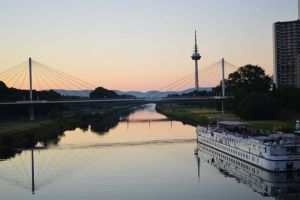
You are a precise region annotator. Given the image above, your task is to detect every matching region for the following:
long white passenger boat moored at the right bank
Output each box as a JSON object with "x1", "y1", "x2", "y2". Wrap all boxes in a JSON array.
[{"x1": 197, "y1": 121, "x2": 300, "y2": 172}]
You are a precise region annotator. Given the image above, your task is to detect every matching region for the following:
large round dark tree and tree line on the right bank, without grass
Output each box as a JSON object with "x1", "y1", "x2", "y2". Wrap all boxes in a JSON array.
[{"x1": 173, "y1": 65, "x2": 300, "y2": 120}]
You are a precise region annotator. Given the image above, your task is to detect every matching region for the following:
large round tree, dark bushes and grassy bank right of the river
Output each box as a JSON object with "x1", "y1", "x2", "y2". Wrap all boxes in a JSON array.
[{"x1": 157, "y1": 65, "x2": 300, "y2": 132}]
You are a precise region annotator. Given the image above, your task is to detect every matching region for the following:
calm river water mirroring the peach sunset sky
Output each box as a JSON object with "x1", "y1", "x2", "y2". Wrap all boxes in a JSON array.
[{"x1": 0, "y1": 104, "x2": 300, "y2": 200}]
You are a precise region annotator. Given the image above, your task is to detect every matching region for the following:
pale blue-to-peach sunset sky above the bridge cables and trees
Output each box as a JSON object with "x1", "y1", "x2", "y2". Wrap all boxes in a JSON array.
[{"x1": 0, "y1": 0, "x2": 298, "y2": 91}]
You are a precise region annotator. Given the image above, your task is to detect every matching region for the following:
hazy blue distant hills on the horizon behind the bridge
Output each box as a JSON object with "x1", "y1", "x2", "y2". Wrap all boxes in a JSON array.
[{"x1": 55, "y1": 88, "x2": 212, "y2": 98}]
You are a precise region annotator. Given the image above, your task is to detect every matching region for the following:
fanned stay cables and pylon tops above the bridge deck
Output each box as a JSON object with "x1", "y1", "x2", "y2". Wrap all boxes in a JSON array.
[{"x1": 0, "y1": 57, "x2": 237, "y2": 97}]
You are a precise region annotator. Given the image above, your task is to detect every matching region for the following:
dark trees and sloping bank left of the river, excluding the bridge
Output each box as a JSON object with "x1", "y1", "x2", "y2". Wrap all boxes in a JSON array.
[{"x1": 0, "y1": 78, "x2": 140, "y2": 159}]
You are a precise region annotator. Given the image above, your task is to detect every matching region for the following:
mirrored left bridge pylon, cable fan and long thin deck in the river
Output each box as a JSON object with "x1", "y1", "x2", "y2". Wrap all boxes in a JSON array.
[{"x1": 0, "y1": 139, "x2": 195, "y2": 194}]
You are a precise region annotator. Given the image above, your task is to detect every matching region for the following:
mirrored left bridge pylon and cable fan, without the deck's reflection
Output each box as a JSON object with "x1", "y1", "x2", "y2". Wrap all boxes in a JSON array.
[{"x1": 0, "y1": 145, "x2": 105, "y2": 194}]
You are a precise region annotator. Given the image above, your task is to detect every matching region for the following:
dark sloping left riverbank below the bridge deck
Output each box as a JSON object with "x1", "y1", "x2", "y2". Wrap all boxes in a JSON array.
[{"x1": 0, "y1": 106, "x2": 136, "y2": 156}]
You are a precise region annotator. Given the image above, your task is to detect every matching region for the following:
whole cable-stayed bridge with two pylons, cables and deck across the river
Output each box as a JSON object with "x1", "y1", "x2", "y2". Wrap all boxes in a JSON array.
[{"x1": 0, "y1": 58, "x2": 237, "y2": 119}]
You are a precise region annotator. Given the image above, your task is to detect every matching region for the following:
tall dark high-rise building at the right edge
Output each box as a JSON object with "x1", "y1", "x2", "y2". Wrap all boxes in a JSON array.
[{"x1": 274, "y1": 0, "x2": 300, "y2": 88}]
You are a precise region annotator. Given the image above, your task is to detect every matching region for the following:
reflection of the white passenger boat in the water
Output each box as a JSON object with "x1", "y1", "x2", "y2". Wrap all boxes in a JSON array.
[{"x1": 198, "y1": 143, "x2": 300, "y2": 199}]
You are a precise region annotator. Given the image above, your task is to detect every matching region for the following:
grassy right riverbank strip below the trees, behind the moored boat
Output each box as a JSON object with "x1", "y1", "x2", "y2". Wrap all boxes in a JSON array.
[{"x1": 156, "y1": 104, "x2": 296, "y2": 132}]
